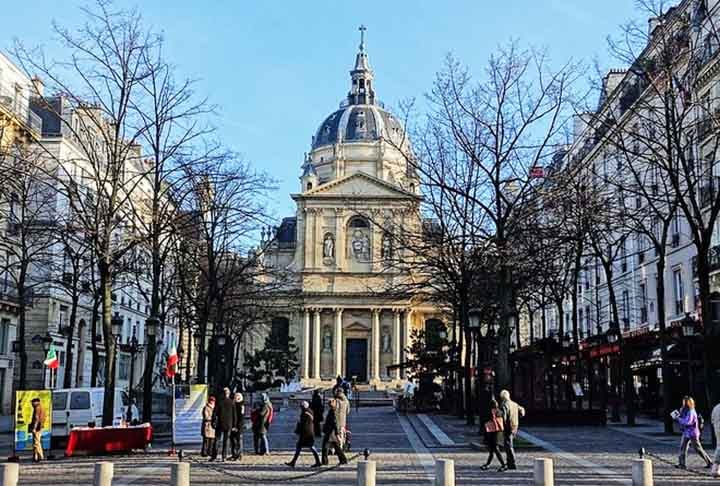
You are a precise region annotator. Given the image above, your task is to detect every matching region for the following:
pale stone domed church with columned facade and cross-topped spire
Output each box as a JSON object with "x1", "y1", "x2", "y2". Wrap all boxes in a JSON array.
[{"x1": 266, "y1": 29, "x2": 444, "y2": 388}]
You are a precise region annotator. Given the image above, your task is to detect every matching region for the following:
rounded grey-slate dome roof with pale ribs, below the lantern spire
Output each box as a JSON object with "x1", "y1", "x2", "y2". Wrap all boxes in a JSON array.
[{"x1": 312, "y1": 105, "x2": 402, "y2": 149}]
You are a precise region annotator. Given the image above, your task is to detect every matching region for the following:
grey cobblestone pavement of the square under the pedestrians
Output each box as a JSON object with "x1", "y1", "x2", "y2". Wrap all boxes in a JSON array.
[{"x1": 9, "y1": 407, "x2": 720, "y2": 486}]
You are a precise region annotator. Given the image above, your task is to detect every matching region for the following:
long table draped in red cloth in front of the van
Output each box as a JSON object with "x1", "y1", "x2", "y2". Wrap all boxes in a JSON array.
[{"x1": 65, "y1": 424, "x2": 152, "y2": 457}]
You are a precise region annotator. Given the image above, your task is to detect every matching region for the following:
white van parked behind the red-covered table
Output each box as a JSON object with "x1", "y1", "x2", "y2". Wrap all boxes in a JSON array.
[{"x1": 52, "y1": 387, "x2": 128, "y2": 440}]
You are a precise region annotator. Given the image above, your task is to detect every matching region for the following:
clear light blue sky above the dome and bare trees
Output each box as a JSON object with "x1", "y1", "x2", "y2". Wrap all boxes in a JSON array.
[{"x1": 0, "y1": 0, "x2": 637, "y2": 216}]
